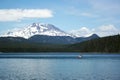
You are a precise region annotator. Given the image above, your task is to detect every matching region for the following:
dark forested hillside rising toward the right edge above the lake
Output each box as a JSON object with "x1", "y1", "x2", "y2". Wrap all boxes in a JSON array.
[{"x1": 69, "y1": 35, "x2": 120, "y2": 53}]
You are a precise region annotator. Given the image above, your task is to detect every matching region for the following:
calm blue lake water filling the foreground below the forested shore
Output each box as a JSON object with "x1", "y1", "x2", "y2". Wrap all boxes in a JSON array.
[{"x1": 0, "y1": 53, "x2": 120, "y2": 80}]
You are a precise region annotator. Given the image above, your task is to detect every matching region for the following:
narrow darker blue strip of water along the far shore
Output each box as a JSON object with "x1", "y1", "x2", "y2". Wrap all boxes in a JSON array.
[{"x1": 0, "y1": 52, "x2": 120, "y2": 59}]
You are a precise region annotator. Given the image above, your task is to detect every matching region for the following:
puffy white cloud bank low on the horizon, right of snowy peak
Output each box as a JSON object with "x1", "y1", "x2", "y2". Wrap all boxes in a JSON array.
[{"x1": 70, "y1": 24, "x2": 120, "y2": 37}]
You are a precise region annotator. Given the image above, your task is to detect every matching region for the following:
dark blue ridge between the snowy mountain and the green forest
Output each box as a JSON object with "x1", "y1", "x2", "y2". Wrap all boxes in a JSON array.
[{"x1": 0, "y1": 34, "x2": 99, "y2": 44}]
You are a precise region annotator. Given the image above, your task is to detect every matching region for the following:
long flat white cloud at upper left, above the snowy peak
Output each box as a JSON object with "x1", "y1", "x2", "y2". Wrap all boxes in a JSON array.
[{"x1": 0, "y1": 9, "x2": 53, "y2": 21}]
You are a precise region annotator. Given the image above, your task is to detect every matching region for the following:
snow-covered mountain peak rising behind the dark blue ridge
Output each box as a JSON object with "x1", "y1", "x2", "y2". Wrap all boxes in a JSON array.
[{"x1": 1, "y1": 23, "x2": 72, "y2": 39}]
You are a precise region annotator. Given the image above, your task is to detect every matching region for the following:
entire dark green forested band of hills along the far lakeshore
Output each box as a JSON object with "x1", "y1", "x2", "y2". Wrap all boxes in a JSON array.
[{"x1": 0, "y1": 35, "x2": 120, "y2": 53}]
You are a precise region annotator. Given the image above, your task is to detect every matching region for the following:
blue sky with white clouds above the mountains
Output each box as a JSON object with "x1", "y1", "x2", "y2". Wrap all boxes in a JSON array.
[{"x1": 0, "y1": 0, "x2": 120, "y2": 37}]
